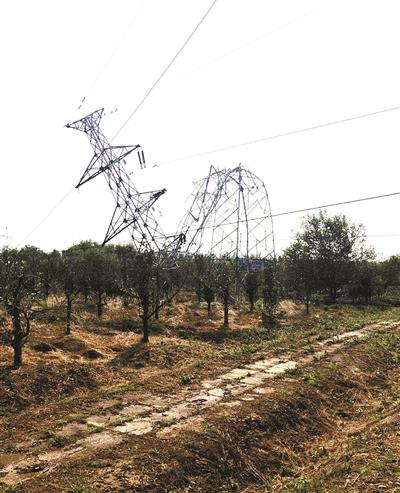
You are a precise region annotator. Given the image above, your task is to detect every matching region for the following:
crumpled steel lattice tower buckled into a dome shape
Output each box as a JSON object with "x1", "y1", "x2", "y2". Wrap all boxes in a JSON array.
[{"x1": 178, "y1": 165, "x2": 275, "y2": 268}]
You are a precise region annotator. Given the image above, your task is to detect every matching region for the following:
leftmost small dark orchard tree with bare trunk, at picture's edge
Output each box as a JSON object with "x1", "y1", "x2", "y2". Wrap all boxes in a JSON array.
[{"x1": 0, "y1": 247, "x2": 45, "y2": 368}]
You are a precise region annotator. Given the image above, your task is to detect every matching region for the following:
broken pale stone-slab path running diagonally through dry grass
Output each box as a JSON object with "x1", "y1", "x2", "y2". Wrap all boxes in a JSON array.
[{"x1": 0, "y1": 322, "x2": 398, "y2": 485}]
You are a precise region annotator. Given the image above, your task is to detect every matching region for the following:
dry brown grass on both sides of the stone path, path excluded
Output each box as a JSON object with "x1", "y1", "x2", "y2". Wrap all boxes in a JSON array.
[{"x1": 0, "y1": 297, "x2": 399, "y2": 493}]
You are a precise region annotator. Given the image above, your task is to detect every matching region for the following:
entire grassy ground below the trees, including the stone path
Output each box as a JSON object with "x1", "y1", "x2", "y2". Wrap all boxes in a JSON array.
[{"x1": 0, "y1": 294, "x2": 400, "y2": 493}]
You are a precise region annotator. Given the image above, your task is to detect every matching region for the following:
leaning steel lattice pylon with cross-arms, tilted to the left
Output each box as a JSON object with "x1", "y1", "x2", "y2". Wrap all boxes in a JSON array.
[{"x1": 66, "y1": 109, "x2": 184, "y2": 252}]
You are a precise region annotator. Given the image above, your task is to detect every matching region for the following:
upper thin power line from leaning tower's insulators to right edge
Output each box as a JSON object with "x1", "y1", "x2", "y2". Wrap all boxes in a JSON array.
[{"x1": 153, "y1": 105, "x2": 400, "y2": 167}]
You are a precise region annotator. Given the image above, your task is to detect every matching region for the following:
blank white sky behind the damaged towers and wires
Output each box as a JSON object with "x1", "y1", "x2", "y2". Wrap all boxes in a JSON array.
[{"x1": 0, "y1": 0, "x2": 400, "y2": 256}]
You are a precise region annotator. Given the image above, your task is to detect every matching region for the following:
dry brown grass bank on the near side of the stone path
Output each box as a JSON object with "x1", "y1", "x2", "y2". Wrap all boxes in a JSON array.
[{"x1": 17, "y1": 324, "x2": 400, "y2": 493}]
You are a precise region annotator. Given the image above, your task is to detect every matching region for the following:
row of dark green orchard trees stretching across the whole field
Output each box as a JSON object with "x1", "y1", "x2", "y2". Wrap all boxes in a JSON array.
[{"x1": 0, "y1": 212, "x2": 400, "y2": 367}]
